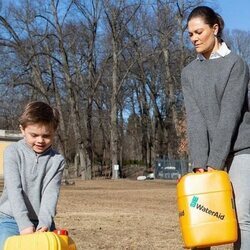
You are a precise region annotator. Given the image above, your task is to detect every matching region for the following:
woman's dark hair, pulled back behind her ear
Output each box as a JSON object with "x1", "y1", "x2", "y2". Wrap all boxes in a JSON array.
[{"x1": 187, "y1": 6, "x2": 224, "y2": 42}]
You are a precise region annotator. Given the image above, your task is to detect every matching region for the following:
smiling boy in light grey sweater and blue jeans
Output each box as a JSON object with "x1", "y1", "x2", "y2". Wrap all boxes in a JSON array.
[{"x1": 0, "y1": 102, "x2": 64, "y2": 250}]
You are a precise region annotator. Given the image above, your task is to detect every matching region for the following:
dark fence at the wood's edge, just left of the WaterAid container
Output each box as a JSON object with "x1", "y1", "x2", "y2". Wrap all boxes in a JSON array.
[{"x1": 155, "y1": 158, "x2": 189, "y2": 180}]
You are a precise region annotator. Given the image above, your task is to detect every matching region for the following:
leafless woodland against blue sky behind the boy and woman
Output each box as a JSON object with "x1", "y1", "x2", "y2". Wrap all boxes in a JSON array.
[{"x1": 0, "y1": 0, "x2": 250, "y2": 179}]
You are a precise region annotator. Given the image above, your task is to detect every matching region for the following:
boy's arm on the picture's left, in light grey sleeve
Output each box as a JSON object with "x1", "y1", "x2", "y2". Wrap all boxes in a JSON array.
[{"x1": 4, "y1": 147, "x2": 33, "y2": 232}]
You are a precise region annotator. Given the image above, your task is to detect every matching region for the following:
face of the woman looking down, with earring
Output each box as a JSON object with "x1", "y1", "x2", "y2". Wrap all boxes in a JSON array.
[{"x1": 188, "y1": 17, "x2": 219, "y2": 59}]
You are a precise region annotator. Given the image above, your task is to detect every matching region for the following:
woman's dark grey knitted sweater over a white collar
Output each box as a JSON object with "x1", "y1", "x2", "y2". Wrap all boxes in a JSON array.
[{"x1": 182, "y1": 52, "x2": 250, "y2": 169}]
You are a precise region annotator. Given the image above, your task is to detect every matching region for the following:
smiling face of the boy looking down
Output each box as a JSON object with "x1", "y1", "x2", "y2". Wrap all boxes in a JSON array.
[{"x1": 20, "y1": 123, "x2": 55, "y2": 154}]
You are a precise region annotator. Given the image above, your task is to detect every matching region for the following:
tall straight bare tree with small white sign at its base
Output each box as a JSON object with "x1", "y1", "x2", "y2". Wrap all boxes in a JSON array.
[{"x1": 103, "y1": 0, "x2": 140, "y2": 178}]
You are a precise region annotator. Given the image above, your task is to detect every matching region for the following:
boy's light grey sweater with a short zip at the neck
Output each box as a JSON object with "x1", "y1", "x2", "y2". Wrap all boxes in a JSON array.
[{"x1": 0, "y1": 139, "x2": 64, "y2": 231}]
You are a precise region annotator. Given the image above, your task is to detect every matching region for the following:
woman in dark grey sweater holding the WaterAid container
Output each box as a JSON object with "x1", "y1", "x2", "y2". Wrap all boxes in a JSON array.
[{"x1": 182, "y1": 6, "x2": 250, "y2": 250}]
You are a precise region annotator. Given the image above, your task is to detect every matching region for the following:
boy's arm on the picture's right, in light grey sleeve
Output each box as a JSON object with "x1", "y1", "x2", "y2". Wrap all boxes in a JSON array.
[{"x1": 37, "y1": 160, "x2": 65, "y2": 230}]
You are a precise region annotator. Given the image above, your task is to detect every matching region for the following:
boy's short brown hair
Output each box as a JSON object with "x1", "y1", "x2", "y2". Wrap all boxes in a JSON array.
[{"x1": 19, "y1": 101, "x2": 59, "y2": 130}]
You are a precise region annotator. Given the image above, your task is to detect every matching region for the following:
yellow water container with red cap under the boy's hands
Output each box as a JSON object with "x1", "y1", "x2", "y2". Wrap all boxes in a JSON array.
[{"x1": 4, "y1": 230, "x2": 76, "y2": 250}]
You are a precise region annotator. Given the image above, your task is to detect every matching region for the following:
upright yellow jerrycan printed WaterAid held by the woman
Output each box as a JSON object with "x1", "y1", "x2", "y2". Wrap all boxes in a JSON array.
[{"x1": 177, "y1": 170, "x2": 238, "y2": 248}]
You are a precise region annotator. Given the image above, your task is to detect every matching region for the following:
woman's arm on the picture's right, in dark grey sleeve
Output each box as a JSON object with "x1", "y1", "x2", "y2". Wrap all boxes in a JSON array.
[{"x1": 208, "y1": 58, "x2": 249, "y2": 169}]
